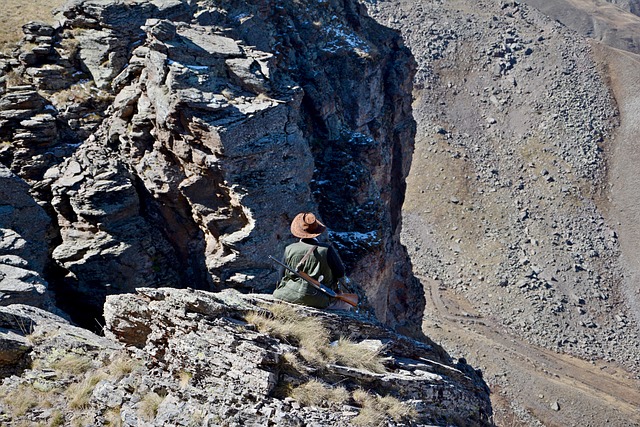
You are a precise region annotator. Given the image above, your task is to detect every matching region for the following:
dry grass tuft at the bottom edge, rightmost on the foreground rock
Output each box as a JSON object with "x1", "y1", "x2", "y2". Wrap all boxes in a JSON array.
[{"x1": 351, "y1": 390, "x2": 418, "y2": 426}]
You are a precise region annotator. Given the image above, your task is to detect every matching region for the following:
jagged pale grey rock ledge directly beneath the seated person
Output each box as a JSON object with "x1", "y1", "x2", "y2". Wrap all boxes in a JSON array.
[{"x1": 104, "y1": 288, "x2": 491, "y2": 426}]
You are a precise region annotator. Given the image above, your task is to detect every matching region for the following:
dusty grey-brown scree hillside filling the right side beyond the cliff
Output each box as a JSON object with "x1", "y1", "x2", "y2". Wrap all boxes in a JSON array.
[{"x1": 370, "y1": 1, "x2": 640, "y2": 426}]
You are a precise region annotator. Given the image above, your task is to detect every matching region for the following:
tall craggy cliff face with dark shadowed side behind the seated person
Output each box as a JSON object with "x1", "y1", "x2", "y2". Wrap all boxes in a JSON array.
[{"x1": 0, "y1": 0, "x2": 424, "y2": 332}]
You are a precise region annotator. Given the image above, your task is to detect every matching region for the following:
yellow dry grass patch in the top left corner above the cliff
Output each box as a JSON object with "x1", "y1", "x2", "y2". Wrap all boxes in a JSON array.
[{"x1": 0, "y1": 0, "x2": 65, "y2": 49}]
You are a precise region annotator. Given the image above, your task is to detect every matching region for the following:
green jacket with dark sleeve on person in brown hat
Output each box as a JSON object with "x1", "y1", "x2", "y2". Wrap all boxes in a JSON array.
[{"x1": 273, "y1": 239, "x2": 344, "y2": 308}]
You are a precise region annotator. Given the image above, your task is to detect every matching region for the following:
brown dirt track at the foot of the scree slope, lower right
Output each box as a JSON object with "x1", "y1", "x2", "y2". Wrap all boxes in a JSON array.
[{"x1": 420, "y1": 277, "x2": 640, "y2": 427}]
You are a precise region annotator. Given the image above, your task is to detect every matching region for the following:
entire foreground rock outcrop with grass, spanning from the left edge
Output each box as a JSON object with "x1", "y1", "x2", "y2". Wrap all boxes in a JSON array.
[{"x1": 0, "y1": 288, "x2": 491, "y2": 426}]
